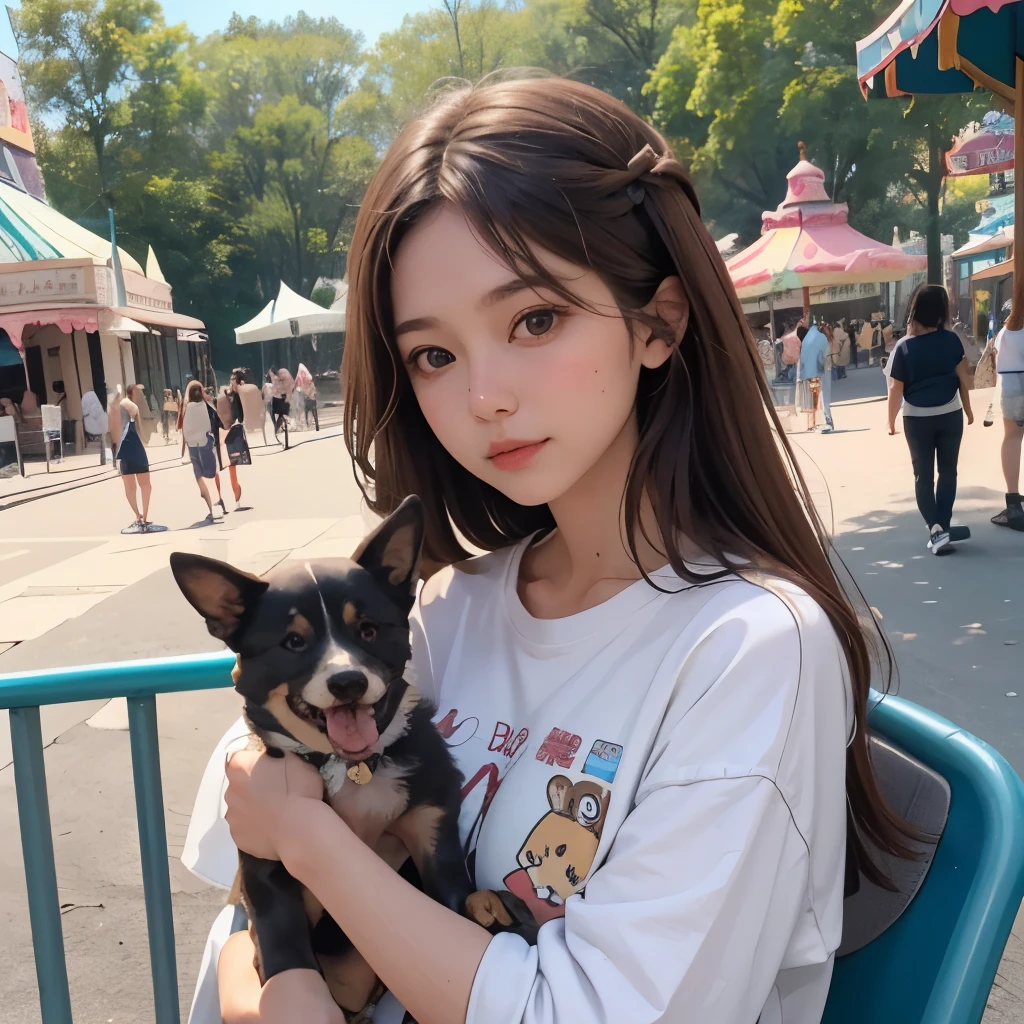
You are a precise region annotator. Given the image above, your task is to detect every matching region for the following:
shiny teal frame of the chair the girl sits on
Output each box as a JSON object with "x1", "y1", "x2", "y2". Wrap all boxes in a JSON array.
[{"x1": 822, "y1": 697, "x2": 1024, "y2": 1024}]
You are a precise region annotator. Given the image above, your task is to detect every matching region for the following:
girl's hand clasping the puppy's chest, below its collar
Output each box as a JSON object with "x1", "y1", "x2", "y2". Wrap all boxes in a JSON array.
[{"x1": 224, "y1": 750, "x2": 325, "y2": 860}]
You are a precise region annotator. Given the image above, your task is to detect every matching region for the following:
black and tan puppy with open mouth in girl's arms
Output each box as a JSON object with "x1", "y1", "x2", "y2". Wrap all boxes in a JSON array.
[{"x1": 171, "y1": 498, "x2": 470, "y2": 1013}]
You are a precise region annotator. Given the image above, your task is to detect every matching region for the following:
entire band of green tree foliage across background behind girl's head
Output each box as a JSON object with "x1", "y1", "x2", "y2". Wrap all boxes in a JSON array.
[{"x1": 15, "y1": 0, "x2": 1007, "y2": 365}]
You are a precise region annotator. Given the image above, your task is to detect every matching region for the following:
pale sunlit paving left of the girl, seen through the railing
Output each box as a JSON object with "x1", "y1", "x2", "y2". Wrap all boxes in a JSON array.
[{"x1": 0, "y1": 419, "x2": 376, "y2": 1024}]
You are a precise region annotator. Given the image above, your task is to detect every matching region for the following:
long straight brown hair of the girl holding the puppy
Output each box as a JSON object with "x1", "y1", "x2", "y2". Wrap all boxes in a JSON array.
[{"x1": 343, "y1": 79, "x2": 910, "y2": 881}]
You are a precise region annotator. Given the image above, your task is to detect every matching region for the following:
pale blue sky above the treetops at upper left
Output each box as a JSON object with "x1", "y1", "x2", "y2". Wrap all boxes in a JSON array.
[{"x1": 0, "y1": 0, "x2": 433, "y2": 56}]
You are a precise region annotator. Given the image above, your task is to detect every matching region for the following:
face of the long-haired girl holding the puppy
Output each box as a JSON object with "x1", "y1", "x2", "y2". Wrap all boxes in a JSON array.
[{"x1": 392, "y1": 206, "x2": 670, "y2": 505}]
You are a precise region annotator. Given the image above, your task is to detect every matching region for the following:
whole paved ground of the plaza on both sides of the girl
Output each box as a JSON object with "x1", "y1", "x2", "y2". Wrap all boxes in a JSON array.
[{"x1": 0, "y1": 370, "x2": 1024, "y2": 1024}]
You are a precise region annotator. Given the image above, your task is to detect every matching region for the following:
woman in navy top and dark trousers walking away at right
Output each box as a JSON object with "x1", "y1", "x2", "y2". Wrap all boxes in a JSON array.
[{"x1": 885, "y1": 285, "x2": 974, "y2": 555}]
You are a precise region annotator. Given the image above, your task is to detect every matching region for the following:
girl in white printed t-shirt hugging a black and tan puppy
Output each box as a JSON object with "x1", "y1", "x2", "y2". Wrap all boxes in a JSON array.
[{"x1": 185, "y1": 80, "x2": 906, "y2": 1024}]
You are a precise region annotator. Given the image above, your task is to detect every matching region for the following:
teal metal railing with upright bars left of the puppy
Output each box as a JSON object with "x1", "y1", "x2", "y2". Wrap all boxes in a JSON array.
[{"x1": 0, "y1": 653, "x2": 234, "y2": 1024}]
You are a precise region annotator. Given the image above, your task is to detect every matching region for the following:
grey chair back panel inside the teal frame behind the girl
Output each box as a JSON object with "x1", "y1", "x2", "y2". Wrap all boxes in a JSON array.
[{"x1": 837, "y1": 735, "x2": 949, "y2": 956}]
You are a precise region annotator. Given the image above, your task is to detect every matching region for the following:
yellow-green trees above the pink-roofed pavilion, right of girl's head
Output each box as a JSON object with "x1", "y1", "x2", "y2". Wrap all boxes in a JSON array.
[{"x1": 648, "y1": 0, "x2": 985, "y2": 280}]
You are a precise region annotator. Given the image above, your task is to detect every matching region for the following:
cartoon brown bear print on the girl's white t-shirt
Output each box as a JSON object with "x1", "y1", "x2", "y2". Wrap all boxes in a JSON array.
[{"x1": 466, "y1": 775, "x2": 611, "y2": 941}]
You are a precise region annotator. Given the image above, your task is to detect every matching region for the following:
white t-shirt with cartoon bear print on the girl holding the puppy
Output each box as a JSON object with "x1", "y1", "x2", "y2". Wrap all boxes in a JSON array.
[{"x1": 182, "y1": 542, "x2": 852, "y2": 1024}]
